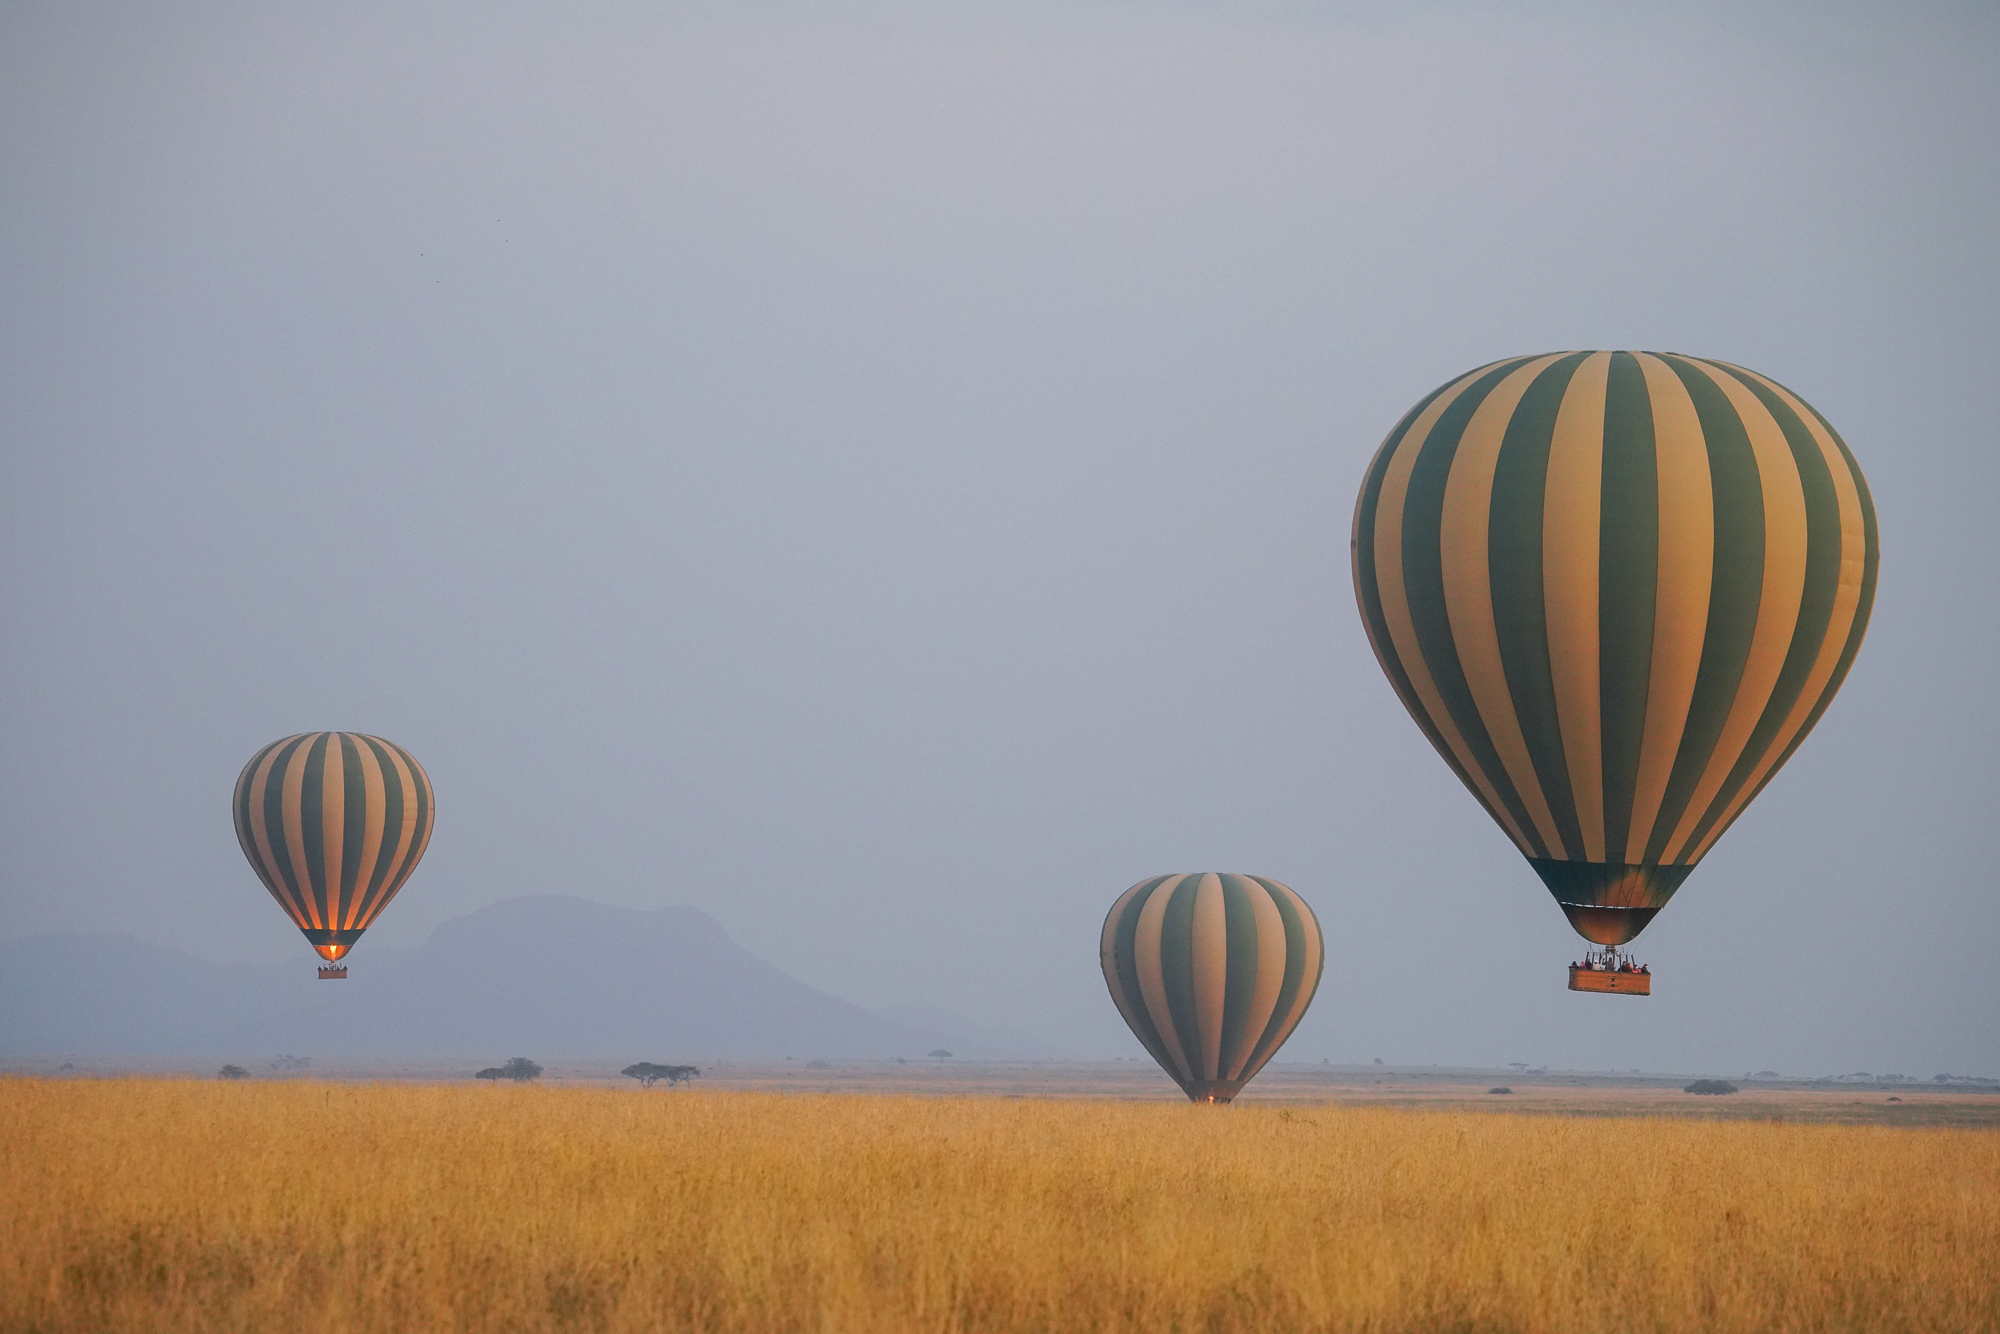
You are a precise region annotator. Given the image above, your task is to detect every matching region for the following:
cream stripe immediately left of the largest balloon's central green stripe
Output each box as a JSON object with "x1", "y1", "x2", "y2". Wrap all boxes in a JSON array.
[{"x1": 1542, "y1": 352, "x2": 1612, "y2": 862}]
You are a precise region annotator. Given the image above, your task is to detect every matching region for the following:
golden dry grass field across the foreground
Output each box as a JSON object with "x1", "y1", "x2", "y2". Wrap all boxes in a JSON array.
[{"x1": 0, "y1": 1078, "x2": 2000, "y2": 1334}]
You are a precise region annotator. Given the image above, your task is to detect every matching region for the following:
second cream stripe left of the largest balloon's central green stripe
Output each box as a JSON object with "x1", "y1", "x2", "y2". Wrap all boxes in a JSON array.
[{"x1": 1440, "y1": 352, "x2": 1570, "y2": 858}]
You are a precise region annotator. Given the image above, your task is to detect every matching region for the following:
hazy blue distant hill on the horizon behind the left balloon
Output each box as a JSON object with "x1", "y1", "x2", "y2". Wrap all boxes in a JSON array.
[{"x1": 0, "y1": 896, "x2": 1050, "y2": 1060}]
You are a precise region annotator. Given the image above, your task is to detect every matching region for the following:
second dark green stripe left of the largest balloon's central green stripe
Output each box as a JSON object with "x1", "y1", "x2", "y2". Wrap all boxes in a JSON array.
[{"x1": 1402, "y1": 356, "x2": 1548, "y2": 856}]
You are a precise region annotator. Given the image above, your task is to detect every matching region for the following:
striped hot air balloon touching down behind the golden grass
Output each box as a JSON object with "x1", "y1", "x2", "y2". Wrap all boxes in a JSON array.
[{"x1": 1098, "y1": 872, "x2": 1324, "y2": 1102}]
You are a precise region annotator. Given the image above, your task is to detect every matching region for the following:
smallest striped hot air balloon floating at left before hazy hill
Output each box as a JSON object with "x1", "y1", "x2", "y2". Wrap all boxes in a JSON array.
[{"x1": 234, "y1": 732, "x2": 432, "y2": 978}]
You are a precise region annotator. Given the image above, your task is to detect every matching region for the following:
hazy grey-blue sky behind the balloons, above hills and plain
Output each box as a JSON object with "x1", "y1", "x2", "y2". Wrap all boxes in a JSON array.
[{"x1": 0, "y1": 0, "x2": 2000, "y2": 1076}]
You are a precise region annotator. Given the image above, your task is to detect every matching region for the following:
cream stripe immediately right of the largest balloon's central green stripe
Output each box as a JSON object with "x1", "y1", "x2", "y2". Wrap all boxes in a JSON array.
[{"x1": 1624, "y1": 352, "x2": 1716, "y2": 862}]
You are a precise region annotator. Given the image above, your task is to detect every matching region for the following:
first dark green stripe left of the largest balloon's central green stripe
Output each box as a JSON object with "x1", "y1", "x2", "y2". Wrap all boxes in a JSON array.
[{"x1": 1486, "y1": 352, "x2": 1590, "y2": 856}]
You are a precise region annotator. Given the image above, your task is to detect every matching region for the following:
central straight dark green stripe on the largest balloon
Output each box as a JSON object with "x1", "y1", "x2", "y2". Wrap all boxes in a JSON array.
[{"x1": 1598, "y1": 352, "x2": 1660, "y2": 860}]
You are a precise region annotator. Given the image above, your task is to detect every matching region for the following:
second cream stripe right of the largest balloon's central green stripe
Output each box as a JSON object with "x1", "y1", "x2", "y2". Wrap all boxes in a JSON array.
[{"x1": 1660, "y1": 358, "x2": 1806, "y2": 862}]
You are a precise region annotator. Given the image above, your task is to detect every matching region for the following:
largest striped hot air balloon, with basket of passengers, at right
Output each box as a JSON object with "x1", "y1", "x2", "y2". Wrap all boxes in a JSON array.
[{"x1": 1352, "y1": 352, "x2": 1878, "y2": 992}]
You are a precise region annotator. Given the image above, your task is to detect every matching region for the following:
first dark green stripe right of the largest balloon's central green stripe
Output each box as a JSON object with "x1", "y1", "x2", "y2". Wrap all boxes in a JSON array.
[{"x1": 1646, "y1": 354, "x2": 1764, "y2": 862}]
